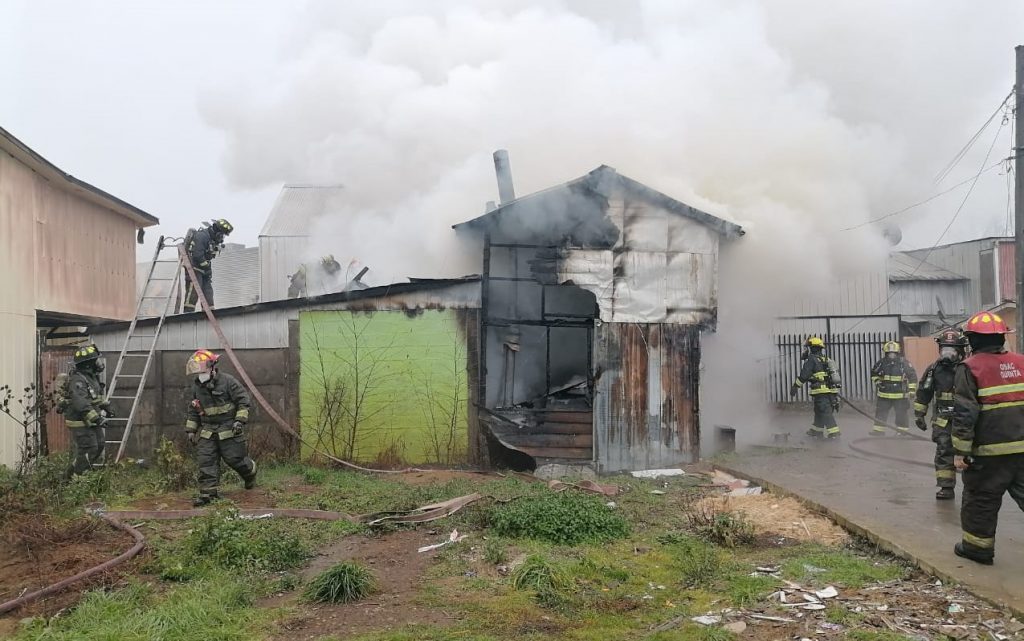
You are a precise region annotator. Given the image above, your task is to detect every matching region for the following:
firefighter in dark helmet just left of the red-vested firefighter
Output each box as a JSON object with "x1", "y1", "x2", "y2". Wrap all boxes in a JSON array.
[{"x1": 913, "y1": 329, "x2": 967, "y2": 501}]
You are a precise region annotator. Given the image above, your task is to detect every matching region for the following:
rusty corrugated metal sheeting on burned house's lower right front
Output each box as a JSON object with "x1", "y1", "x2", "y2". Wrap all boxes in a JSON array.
[{"x1": 594, "y1": 323, "x2": 700, "y2": 472}]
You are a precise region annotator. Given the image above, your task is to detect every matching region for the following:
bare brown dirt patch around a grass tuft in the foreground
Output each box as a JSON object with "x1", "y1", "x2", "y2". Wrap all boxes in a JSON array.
[{"x1": 260, "y1": 530, "x2": 452, "y2": 641}]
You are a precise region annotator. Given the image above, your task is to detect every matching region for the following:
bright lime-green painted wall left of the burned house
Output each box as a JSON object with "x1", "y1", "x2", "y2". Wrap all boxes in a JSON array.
[{"x1": 299, "y1": 310, "x2": 469, "y2": 465}]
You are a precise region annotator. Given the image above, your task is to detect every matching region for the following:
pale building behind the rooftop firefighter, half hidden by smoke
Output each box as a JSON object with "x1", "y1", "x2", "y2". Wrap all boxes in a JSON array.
[{"x1": 258, "y1": 184, "x2": 346, "y2": 304}]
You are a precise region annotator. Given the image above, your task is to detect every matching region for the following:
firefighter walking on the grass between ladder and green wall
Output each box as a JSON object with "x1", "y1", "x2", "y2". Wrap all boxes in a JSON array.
[{"x1": 185, "y1": 349, "x2": 256, "y2": 507}]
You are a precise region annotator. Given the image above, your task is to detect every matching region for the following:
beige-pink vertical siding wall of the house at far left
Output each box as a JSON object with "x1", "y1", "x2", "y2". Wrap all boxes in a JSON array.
[{"x1": 0, "y1": 152, "x2": 136, "y2": 465}]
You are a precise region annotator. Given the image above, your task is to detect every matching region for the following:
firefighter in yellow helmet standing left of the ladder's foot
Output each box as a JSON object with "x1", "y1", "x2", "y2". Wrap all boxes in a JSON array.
[{"x1": 62, "y1": 344, "x2": 114, "y2": 477}]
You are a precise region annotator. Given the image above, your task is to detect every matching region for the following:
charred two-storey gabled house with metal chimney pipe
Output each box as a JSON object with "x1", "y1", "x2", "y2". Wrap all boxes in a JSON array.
[{"x1": 455, "y1": 152, "x2": 743, "y2": 472}]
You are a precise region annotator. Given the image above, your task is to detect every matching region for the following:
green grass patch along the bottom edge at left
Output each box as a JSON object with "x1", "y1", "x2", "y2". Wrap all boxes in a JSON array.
[{"x1": 14, "y1": 574, "x2": 269, "y2": 641}]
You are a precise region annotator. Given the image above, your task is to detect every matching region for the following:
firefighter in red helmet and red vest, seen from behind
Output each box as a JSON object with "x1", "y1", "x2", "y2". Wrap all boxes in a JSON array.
[{"x1": 952, "y1": 311, "x2": 1024, "y2": 565}]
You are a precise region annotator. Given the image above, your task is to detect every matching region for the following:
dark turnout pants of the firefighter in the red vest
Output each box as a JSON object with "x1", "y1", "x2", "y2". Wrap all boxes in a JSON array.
[{"x1": 961, "y1": 454, "x2": 1024, "y2": 558}]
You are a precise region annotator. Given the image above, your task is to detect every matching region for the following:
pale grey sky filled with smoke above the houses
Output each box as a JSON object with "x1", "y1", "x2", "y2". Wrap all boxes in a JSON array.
[{"x1": 0, "y1": 0, "x2": 1024, "y2": 276}]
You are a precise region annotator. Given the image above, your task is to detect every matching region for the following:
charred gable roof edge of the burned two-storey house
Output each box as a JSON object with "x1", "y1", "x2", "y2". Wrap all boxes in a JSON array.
[{"x1": 452, "y1": 165, "x2": 745, "y2": 238}]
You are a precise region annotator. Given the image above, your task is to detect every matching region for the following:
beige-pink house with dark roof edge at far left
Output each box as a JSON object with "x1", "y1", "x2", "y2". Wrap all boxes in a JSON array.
[{"x1": 0, "y1": 124, "x2": 159, "y2": 466}]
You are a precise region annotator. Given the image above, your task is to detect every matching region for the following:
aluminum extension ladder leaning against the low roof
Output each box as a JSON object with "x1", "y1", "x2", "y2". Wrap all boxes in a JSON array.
[{"x1": 103, "y1": 237, "x2": 184, "y2": 463}]
